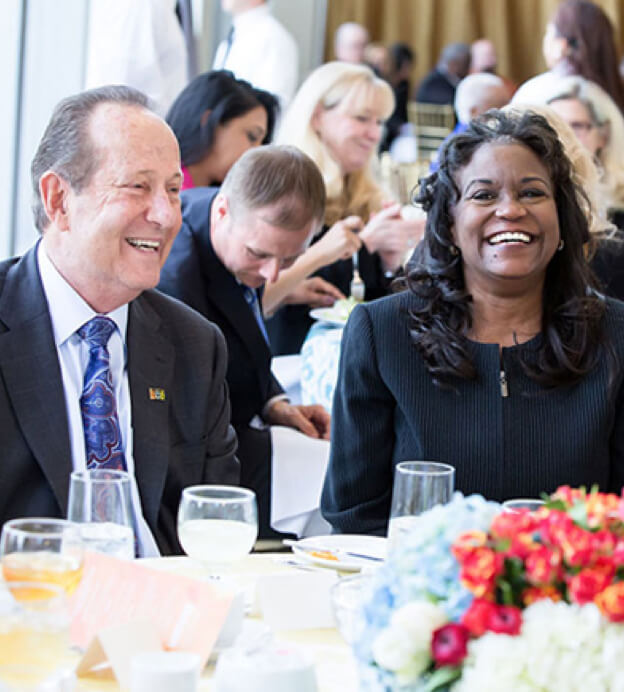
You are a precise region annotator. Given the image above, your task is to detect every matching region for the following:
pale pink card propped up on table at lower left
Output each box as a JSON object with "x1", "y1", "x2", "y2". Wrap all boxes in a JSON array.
[{"x1": 69, "y1": 552, "x2": 234, "y2": 674}]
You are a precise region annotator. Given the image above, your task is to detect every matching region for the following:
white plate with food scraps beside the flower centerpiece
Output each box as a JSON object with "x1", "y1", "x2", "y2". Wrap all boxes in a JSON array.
[{"x1": 292, "y1": 534, "x2": 387, "y2": 572}]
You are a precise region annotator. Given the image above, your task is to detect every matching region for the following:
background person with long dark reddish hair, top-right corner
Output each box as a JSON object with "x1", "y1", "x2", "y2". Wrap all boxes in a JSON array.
[{"x1": 514, "y1": 0, "x2": 624, "y2": 112}]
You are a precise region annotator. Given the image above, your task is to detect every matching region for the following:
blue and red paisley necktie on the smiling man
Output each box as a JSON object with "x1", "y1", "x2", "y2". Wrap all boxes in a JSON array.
[{"x1": 78, "y1": 316, "x2": 126, "y2": 471}]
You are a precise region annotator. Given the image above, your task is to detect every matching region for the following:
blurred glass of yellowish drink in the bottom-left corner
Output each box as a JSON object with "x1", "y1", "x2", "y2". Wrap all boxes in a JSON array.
[{"x1": 0, "y1": 582, "x2": 74, "y2": 690}]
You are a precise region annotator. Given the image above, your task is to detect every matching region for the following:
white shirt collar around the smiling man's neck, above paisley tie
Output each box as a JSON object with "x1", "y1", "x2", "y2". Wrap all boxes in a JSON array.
[{"x1": 37, "y1": 243, "x2": 128, "y2": 347}]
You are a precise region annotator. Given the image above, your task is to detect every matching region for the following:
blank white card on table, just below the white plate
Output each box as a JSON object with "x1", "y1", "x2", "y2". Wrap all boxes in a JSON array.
[{"x1": 257, "y1": 570, "x2": 338, "y2": 630}]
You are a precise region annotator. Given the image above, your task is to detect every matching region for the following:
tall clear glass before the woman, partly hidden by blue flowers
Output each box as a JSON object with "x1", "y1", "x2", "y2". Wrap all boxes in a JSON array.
[{"x1": 388, "y1": 461, "x2": 455, "y2": 552}]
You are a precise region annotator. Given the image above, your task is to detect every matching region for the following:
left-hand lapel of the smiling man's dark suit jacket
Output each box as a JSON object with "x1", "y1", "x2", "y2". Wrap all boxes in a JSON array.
[{"x1": 0, "y1": 247, "x2": 72, "y2": 513}]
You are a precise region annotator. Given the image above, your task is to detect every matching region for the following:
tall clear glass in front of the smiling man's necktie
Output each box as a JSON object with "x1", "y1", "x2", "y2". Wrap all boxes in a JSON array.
[{"x1": 67, "y1": 469, "x2": 134, "y2": 560}]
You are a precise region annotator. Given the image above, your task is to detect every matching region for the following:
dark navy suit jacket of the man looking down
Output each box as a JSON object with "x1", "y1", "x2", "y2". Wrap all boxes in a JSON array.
[{"x1": 158, "y1": 187, "x2": 284, "y2": 538}]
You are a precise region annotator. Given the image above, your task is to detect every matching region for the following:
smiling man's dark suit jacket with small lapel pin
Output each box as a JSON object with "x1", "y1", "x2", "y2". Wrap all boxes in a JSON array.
[{"x1": 0, "y1": 248, "x2": 239, "y2": 554}]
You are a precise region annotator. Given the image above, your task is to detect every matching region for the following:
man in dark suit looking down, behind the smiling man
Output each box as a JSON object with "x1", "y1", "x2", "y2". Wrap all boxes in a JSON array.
[{"x1": 159, "y1": 146, "x2": 329, "y2": 537}]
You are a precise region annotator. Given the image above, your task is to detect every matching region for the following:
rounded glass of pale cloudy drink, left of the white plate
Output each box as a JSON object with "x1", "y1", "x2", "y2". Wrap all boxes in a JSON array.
[{"x1": 178, "y1": 485, "x2": 258, "y2": 569}]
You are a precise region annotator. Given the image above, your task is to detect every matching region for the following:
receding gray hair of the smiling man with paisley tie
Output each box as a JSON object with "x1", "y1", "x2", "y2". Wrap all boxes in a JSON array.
[{"x1": 30, "y1": 86, "x2": 150, "y2": 233}]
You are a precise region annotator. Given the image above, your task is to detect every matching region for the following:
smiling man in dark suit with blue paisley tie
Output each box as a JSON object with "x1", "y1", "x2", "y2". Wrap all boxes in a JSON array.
[{"x1": 0, "y1": 87, "x2": 239, "y2": 554}]
